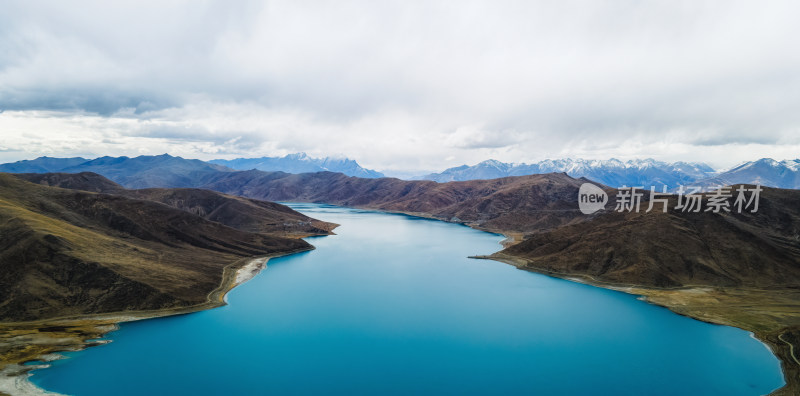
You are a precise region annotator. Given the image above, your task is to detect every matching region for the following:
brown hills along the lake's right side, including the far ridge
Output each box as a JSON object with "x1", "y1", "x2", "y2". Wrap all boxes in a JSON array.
[{"x1": 195, "y1": 171, "x2": 800, "y2": 395}]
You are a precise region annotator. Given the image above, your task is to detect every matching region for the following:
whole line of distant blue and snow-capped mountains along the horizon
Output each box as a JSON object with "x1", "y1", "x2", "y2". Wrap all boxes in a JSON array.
[{"x1": 0, "y1": 153, "x2": 800, "y2": 191}]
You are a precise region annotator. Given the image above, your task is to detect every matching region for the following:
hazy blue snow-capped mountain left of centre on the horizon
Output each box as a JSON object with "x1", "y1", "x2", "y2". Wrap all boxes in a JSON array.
[{"x1": 208, "y1": 153, "x2": 383, "y2": 178}]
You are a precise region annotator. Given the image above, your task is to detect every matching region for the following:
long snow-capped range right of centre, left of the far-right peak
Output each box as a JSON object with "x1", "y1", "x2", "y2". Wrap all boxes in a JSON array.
[{"x1": 423, "y1": 158, "x2": 715, "y2": 189}]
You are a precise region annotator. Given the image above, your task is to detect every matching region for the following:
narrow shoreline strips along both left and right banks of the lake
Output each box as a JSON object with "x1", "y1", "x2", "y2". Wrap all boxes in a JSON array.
[{"x1": 0, "y1": 205, "x2": 800, "y2": 396}]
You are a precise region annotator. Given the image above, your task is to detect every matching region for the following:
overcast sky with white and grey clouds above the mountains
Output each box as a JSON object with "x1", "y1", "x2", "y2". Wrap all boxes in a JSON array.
[{"x1": 0, "y1": 0, "x2": 800, "y2": 172}]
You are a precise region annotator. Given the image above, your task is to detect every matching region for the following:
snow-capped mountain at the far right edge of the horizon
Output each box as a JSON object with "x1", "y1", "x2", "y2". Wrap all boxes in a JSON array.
[{"x1": 696, "y1": 158, "x2": 800, "y2": 189}]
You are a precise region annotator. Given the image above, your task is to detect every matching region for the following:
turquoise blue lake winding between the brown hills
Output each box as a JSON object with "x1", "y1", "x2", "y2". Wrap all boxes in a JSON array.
[{"x1": 31, "y1": 204, "x2": 783, "y2": 396}]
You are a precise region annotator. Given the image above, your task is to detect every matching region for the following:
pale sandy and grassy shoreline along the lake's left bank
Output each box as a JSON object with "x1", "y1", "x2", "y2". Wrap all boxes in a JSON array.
[{"x1": 0, "y1": 246, "x2": 314, "y2": 396}]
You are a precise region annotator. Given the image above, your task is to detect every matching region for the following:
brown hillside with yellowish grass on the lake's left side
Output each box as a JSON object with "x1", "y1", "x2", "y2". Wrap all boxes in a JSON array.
[{"x1": 0, "y1": 174, "x2": 310, "y2": 321}]
